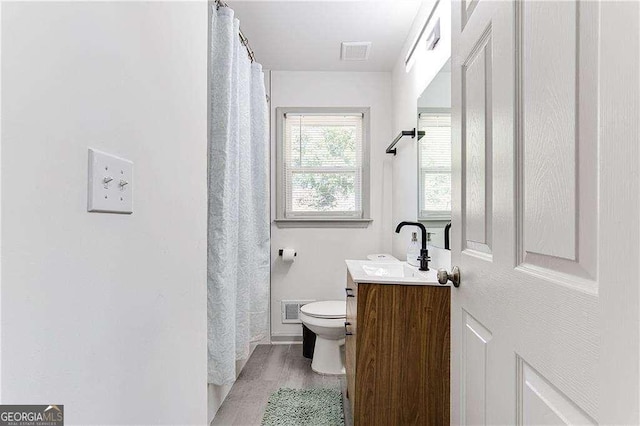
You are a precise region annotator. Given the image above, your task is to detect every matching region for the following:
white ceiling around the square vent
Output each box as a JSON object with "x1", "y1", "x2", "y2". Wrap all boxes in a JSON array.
[{"x1": 227, "y1": 0, "x2": 421, "y2": 71}]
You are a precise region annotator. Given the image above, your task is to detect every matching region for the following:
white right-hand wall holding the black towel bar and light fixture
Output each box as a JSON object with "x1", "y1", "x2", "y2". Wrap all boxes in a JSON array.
[{"x1": 391, "y1": 0, "x2": 451, "y2": 260}]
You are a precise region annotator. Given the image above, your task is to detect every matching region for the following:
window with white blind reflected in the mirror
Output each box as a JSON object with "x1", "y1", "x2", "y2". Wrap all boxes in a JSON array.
[{"x1": 418, "y1": 113, "x2": 451, "y2": 220}]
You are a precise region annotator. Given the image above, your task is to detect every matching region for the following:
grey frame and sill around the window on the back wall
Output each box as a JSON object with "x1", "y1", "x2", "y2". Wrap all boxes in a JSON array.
[{"x1": 274, "y1": 107, "x2": 372, "y2": 228}]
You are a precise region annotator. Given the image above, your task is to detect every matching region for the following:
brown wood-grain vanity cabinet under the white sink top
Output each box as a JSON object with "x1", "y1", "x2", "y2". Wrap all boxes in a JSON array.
[{"x1": 345, "y1": 274, "x2": 451, "y2": 426}]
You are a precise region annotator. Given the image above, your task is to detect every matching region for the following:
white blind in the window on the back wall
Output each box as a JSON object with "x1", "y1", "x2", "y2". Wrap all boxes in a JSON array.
[{"x1": 282, "y1": 113, "x2": 363, "y2": 219}]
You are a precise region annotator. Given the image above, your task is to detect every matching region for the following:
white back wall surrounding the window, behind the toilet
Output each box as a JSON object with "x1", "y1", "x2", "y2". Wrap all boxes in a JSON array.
[{"x1": 271, "y1": 71, "x2": 392, "y2": 339}]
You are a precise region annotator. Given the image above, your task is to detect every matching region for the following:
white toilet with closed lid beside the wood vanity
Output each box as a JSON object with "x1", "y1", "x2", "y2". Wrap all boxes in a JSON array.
[{"x1": 300, "y1": 300, "x2": 347, "y2": 374}]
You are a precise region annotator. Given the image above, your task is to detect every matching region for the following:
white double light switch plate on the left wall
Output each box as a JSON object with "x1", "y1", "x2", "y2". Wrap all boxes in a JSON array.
[{"x1": 87, "y1": 148, "x2": 133, "y2": 214}]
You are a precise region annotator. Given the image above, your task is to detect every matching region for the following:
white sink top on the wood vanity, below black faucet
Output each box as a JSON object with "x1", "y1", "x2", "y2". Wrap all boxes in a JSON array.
[{"x1": 345, "y1": 260, "x2": 440, "y2": 286}]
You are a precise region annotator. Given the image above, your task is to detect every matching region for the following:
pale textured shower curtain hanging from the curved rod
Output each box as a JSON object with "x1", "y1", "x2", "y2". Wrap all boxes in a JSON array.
[{"x1": 207, "y1": 7, "x2": 269, "y2": 385}]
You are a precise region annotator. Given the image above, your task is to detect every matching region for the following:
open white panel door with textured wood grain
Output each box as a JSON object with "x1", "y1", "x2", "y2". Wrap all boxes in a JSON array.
[{"x1": 451, "y1": 0, "x2": 640, "y2": 425}]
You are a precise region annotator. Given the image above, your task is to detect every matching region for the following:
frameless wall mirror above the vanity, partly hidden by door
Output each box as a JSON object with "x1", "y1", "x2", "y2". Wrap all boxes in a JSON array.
[{"x1": 417, "y1": 60, "x2": 451, "y2": 248}]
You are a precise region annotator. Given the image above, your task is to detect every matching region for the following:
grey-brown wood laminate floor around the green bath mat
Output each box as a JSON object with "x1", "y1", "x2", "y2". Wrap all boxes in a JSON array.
[{"x1": 211, "y1": 345, "x2": 353, "y2": 426}]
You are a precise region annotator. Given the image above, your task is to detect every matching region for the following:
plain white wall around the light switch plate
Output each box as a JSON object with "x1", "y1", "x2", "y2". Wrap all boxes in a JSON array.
[{"x1": 1, "y1": 1, "x2": 207, "y2": 425}]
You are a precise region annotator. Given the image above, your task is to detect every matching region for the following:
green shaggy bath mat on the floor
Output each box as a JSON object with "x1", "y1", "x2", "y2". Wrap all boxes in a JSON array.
[{"x1": 262, "y1": 388, "x2": 344, "y2": 426}]
